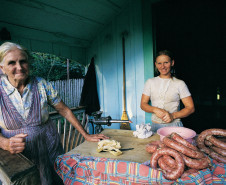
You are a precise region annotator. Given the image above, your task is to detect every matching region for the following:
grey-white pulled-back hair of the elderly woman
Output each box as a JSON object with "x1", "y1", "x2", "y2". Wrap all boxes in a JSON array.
[{"x1": 0, "y1": 42, "x2": 29, "y2": 66}]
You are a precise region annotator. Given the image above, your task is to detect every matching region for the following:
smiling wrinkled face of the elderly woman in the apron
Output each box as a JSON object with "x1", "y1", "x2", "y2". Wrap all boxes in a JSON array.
[{"x1": 1, "y1": 49, "x2": 29, "y2": 81}]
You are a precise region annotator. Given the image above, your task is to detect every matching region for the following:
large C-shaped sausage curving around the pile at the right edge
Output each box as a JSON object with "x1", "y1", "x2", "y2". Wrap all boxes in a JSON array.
[{"x1": 196, "y1": 128, "x2": 226, "y2": 156}]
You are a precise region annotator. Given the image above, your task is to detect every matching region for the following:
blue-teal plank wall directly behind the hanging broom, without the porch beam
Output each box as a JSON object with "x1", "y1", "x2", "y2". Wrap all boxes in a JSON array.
[{"x1": 87, "y1": 1, "x2": 153, "y2": 130}]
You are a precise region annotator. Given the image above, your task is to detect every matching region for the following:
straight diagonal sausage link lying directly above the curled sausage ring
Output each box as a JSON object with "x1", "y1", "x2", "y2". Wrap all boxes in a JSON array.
[{"x1": 163, "y1": 137, "x2": 205, "y2": 159}]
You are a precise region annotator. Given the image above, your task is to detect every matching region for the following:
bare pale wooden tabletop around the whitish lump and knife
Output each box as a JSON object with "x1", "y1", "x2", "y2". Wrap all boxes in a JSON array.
[{"x1": 67, "y1": 129, "x2": 160, "y2": 163}]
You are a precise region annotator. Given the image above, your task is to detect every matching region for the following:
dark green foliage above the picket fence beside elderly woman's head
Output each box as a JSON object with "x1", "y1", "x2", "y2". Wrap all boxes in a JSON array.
[{"x1": 30, "y1": 52, "x2": 85, "y2": 81}]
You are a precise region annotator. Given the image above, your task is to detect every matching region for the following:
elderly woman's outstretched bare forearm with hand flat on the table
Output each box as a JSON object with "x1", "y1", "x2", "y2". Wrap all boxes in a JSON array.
[{"x1": 54, "y1": 101, "x2": 108, "y2": 142}]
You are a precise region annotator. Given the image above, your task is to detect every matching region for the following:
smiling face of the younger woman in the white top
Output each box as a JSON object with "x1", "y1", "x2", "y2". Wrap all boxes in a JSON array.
[{"x1": 155, "y1": 55, "x2": 174, "y2": 76}]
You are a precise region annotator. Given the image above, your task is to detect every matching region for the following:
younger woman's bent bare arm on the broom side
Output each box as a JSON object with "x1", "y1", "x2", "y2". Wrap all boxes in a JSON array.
[{"x1": 140, "y1": 94, "x2": 168, "y2": 119}]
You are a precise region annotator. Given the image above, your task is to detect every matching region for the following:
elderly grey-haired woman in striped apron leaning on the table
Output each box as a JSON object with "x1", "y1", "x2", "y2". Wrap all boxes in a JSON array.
[{"x1": 0, "y1": 42, "x2": 108, "y2": 185}]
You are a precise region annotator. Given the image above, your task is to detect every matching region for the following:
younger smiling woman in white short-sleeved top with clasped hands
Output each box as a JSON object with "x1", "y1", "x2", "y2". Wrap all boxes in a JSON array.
[{"x1": 140, "y1": 50, "x2": 195, "y2": 132}]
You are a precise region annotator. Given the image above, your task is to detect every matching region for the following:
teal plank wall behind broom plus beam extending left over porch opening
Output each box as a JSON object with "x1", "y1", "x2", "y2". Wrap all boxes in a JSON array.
[{"x1": 0, "y1": 0, "x2": 157, "y2": 130}]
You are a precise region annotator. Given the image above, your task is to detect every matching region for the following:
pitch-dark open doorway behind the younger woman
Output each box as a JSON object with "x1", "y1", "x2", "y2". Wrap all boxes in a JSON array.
[{"x1": 152, "y1": 0, "x2": 226, "y2": 133}]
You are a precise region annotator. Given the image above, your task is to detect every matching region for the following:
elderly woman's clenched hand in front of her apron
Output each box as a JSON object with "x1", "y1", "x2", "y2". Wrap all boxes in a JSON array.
[{"x1": 3, "y1": 134, "x2": 27, "y2": 154}]
